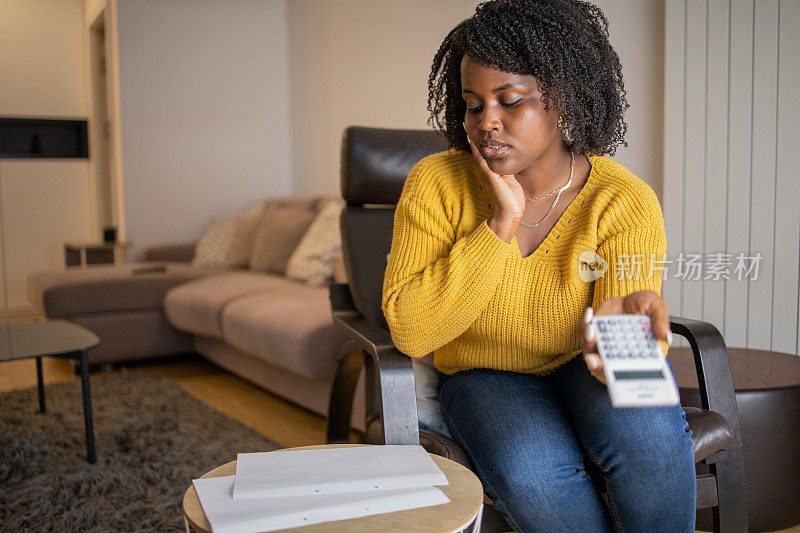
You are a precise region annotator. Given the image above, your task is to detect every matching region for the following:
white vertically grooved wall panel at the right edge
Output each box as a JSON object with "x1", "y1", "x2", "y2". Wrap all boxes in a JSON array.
[{"x1": 663, "y1": 0, "x2": 800, "y2": 354}]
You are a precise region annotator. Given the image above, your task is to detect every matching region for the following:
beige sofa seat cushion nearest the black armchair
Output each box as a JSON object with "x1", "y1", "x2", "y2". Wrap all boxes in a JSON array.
[{"x1": 222, "y1": 279, "x2": 344, "y2": 378}]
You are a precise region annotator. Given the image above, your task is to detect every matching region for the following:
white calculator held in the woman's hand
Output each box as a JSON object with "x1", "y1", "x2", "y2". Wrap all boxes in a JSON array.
[{"x1": 592, "y1": 315, "x2": 679, "y2": 407}]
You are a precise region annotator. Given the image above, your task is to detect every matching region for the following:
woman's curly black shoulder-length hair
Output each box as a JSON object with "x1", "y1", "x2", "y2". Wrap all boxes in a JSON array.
[{"x1": 428, "y1": 0, "x2": 629, "y2": 155}]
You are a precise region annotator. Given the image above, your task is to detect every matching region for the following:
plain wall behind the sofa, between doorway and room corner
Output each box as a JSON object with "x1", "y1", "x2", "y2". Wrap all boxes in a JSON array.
[{"x1": 118, "y1": 0, "x2": 292, "y2": 251}]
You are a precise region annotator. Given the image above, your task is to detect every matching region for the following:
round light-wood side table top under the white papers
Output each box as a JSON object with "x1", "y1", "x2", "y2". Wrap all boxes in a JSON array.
[{"x1": 183, "y1": 444, "x2": 483, "y2": 533}]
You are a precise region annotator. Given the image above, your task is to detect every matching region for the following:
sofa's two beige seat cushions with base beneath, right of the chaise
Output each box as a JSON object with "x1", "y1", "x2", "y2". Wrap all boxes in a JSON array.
[{"x1": 164, "y1": 271, "x2": 354, "y2": 425}]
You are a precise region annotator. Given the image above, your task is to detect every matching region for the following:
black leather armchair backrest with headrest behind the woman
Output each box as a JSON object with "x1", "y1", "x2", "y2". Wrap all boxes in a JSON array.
[{"x1": 341, "y1": 126, "x2": 447, "y2": 328}]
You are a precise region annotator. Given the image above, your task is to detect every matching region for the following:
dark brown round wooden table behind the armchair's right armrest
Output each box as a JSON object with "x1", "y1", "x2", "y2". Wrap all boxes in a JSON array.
[{"x1": 669, "y1": 348, "x2": 800, "y2": 531}]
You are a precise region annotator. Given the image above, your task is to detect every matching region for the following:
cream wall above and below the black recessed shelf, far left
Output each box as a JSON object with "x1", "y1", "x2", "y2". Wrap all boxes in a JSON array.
[{"x1": 0, "y1": 0, "x2": 91, "y2": 314}]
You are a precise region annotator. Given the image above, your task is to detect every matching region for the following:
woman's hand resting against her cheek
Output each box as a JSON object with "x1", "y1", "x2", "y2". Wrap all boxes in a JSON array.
[{"x1": 464, "y1": 122, "x2": 525, "y2": 242}]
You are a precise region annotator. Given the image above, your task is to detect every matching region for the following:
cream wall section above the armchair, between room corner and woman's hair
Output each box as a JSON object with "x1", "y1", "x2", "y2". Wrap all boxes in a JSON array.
[{"x1": 289, "y1": 0, "x2": 477, "y2": 194}]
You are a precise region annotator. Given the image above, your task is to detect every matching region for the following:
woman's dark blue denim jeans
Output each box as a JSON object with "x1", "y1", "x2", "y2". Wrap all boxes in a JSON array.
[{"x1": 439, "y1": 356, "x2": 697, "y2": 533}]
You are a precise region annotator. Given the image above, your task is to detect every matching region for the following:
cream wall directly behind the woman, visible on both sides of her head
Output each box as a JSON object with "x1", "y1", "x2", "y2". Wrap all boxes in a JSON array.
[{"x1": 289, "y1": 0, "x2": 664, "y2": 197}]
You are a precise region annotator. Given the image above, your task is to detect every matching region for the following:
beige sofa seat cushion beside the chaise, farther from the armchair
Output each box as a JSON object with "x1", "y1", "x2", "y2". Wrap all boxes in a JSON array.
[{"x1": 164, "y1": 271, "x2": 284, "y2": 339}]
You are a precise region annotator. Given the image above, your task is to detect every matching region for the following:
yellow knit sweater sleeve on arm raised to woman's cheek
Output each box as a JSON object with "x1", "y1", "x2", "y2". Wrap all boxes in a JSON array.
[{"x1": 382, "y1": 160, "x2": 514, "y2": 357}]
